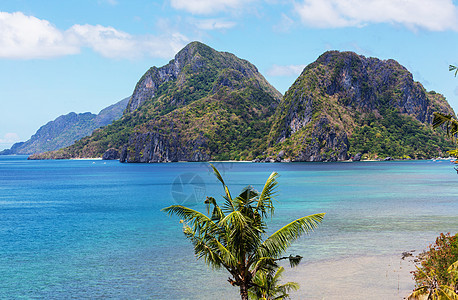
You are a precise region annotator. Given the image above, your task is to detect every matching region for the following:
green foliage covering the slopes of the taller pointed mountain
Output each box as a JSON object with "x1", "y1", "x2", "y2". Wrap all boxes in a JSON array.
[{"x1": 33, "y1": 42, "x2": 280, "y2": 160}]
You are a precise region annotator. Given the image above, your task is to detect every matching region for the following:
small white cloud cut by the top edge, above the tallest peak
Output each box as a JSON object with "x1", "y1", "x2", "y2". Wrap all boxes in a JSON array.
[{"x1": 170, "y1": 0, "x2": 253, "y2": 14}]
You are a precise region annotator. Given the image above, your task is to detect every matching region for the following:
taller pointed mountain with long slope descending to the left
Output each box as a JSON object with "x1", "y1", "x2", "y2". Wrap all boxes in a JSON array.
[{"x1": 31, "y1": 42, "x2": 281, "y2": 162}]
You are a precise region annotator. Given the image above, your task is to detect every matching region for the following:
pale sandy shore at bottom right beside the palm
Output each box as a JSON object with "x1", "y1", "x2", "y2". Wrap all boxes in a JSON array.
[{"x1": 283, "y1": 255, "x2": 415, "y2": 300}]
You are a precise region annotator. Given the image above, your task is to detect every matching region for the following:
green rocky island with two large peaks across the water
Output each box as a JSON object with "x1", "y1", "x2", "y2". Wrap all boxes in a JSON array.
[{"x1": 30, "y1": 42, "x2": 455, "y2": 162}]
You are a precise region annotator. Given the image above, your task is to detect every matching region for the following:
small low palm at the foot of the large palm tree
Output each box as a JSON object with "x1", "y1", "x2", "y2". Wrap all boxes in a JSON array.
[{"x1": 248, "y1": 267, "x2": 299, "y2": 300}]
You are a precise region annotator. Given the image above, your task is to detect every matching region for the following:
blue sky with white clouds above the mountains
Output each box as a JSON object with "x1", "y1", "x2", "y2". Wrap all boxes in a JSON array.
[{"x1": 0, "y1": 0, "x2": 458, "y2": 150}]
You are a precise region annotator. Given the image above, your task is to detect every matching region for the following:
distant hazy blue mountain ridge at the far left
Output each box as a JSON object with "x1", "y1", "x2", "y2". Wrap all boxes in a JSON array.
[{"x1": 0, "y1": 98, "x2": 129, "y2": 155}]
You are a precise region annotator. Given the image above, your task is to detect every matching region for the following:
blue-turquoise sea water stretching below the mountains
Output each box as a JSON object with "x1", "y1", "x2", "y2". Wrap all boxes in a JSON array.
[{"x1": 0, "y1": 156, "x2": 458, "y2": 299}]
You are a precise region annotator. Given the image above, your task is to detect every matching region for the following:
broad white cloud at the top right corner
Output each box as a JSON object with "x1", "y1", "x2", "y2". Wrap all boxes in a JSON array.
[{"x1": 294, "y1": 0, "x2": 458, "y2": 31}]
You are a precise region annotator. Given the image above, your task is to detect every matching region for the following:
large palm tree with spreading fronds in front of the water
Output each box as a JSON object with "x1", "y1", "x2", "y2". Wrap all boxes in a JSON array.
[{"x1": 163, "y1": 165, "x2": 324, "y2": 300}]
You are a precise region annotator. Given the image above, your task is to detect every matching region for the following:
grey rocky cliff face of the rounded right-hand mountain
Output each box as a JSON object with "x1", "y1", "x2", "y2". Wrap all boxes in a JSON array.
[{"x1": 268, "y1": 51, "x2": 454, "y2": 161}]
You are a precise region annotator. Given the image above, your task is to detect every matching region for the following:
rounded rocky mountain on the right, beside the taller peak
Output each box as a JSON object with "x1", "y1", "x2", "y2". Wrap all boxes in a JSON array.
[{"x1": 261, "y1": 51, "x2": 455, "y2": 161}]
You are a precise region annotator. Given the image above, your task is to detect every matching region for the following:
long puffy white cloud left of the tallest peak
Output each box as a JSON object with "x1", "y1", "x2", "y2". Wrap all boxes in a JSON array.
[{"x1": 0, "y1": 12, "x2": 189, "y2": 59}]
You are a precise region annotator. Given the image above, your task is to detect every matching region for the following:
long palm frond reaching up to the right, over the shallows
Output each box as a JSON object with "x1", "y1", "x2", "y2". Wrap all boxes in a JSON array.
[{"x1": 259, "y1": 213, "x2": 325, "y2": 257}]
